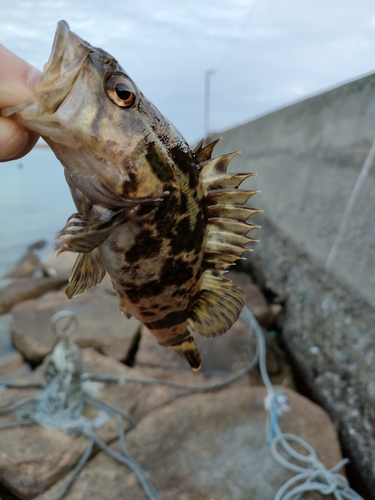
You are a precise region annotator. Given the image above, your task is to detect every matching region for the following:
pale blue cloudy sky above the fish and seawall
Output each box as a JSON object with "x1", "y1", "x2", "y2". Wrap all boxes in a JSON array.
[{"x1": 0, "y1": 0, "x2": 375, "y2": 143}]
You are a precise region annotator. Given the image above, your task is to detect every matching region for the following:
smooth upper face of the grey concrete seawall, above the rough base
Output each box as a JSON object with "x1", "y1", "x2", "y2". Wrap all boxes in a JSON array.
[{"x1": 217, "y1": 75, "x2": 375, "y2": 306}]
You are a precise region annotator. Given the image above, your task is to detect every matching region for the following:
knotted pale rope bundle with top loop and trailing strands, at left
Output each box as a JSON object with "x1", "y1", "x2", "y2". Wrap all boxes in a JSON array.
[{"x1": 0, "y1": 311, "x2": 161, "y2": 500}]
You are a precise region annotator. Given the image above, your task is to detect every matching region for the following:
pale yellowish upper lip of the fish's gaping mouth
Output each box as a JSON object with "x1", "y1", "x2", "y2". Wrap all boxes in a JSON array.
[{"x1": 34, "y1": 21, "x2": 94, "y2": 114}]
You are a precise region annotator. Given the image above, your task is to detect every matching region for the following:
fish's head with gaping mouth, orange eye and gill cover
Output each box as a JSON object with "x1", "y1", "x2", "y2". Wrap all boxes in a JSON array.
[{"x1": 2, "y1": 21, "x2": 188, "y2": 207}]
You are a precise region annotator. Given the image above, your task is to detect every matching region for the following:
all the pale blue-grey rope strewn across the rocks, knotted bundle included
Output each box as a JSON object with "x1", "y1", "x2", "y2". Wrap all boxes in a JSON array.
[{"x1": 0, "y1": 306, "x2": 363, "y2": 500}]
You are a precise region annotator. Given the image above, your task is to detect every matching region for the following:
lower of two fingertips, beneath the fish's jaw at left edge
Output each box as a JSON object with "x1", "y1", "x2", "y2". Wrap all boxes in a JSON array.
[{"x1": 0, "y1": 117, "x2": 39, "y2": 162}]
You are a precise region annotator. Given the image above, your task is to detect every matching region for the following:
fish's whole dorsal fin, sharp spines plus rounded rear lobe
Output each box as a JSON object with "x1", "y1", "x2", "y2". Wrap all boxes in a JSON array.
[{"x1": 189, "y1": 140, "x2": 261, "y2": 337}]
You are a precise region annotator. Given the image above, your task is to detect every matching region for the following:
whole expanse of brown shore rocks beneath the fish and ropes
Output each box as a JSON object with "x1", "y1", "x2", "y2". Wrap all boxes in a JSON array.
[{"x1": 0, "y1": 244, "x2": 350, "y2": 500}]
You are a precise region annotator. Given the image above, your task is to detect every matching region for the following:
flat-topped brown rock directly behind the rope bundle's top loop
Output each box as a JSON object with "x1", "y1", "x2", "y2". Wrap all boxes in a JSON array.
[{"x1": 12, "y1": 287, "x2": 139, "y2": 363}]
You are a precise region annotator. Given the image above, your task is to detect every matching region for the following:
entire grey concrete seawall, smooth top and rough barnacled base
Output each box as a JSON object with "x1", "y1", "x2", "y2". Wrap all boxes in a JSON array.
[{"x1": 215, "y1": 74, "x2": 375, "y2": 498}]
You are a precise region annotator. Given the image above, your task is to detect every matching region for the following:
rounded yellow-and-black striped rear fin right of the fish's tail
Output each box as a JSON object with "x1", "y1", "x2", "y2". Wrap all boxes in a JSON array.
[{"x1": 188, "y1": 271, "x2": 245, "y2": 337}]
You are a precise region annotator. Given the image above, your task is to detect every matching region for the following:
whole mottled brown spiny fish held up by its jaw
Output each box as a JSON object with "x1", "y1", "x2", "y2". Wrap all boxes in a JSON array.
[{"x1": 2, "y1": 21, "x2": 261, "y2": 370}]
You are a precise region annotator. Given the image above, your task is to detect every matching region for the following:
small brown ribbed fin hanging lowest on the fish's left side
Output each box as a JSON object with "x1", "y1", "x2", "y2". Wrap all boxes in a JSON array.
[{"x1": 65, "y1": 248, "x2": 106, "y2": 300}]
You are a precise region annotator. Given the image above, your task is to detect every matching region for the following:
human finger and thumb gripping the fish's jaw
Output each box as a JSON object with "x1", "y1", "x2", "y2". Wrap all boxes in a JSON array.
[{"x1": 0, "y1": 44, "x2": 42, "y2": 162}]
